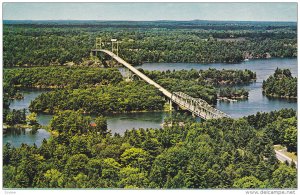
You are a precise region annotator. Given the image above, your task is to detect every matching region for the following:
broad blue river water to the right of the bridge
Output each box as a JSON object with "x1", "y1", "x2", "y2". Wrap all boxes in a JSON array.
[{"x1": 138, "y1": 58, "x2": 298, "y2": 118}]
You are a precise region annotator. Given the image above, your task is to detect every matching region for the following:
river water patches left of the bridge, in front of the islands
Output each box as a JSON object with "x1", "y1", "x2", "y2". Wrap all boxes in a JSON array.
[{"x1": 3, "y1": 90, "x2": 168, "y2": 147}]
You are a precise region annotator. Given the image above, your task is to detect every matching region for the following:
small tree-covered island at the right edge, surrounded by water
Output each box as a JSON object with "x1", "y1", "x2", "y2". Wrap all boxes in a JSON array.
[{"x1": 263, "y1": 68, "x2": 297, "y2": 98}]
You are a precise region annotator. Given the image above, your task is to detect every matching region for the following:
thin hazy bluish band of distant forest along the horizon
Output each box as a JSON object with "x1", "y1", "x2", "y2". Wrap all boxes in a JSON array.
[{"x1": 3, "y1": 20, "x2": 297, "y2": 30}]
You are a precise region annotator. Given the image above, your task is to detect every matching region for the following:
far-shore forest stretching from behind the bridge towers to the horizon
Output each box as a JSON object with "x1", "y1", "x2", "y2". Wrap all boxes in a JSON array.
[{"x1": 3, "y1": 21, "x2": 297, "y2": 67}]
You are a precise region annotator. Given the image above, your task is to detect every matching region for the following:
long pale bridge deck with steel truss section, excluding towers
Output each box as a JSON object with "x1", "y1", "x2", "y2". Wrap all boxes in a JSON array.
[{"x1": 92, "y1": 49, "x2": 230, "y2": 119}]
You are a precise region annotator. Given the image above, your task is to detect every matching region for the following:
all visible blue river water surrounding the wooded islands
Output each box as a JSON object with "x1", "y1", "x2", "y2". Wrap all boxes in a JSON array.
[{"x1": 3, "y1": 58, "x2": 297, "y2": 146}]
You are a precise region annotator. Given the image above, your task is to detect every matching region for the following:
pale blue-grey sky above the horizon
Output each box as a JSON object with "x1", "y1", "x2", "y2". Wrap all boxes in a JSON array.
[{"x1": 2, "y1": 3, "x2": 297, "y2": 22}]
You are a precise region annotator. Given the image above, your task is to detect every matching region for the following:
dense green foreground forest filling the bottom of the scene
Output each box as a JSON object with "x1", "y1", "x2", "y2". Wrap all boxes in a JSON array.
[{"x1": 3, "y1": 109, "x2": 297, "y2": 189}]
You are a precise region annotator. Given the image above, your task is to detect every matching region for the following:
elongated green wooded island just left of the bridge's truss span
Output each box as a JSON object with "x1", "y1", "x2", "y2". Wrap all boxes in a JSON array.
[{"x1": 29, "y1": 81, "x2": 165, "y2": 114}]
